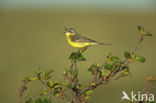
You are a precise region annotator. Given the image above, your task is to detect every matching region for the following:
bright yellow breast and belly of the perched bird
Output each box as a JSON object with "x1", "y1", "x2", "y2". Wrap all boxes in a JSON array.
[{"x1": 67, "y1": 37, "x2": 96, "y2": 48}]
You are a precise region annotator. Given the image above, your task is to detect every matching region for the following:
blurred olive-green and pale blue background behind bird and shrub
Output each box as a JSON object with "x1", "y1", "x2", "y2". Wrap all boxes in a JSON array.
[{"x1": 0, "y1": 0, "x2": 156, "y2": 103}]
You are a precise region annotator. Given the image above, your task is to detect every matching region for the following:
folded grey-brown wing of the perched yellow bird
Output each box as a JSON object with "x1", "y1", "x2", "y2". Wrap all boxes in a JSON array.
[{"x1": 71, "y1": 34, "x2": 97, "y2": 43}]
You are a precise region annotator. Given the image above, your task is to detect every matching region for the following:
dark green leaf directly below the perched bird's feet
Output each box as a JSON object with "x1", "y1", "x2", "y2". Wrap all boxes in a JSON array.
[{"x1": 69, "y1": 52, "x2": 86, "y2": 61}]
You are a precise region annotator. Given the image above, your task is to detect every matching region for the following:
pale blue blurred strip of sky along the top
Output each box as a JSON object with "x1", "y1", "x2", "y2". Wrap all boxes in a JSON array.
[{"x1": 0, "y1": 0, "x2": 156, "y2": 10}]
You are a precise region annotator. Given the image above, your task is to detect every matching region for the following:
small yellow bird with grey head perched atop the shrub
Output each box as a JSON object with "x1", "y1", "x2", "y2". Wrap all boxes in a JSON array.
[{"x1": 64, "y1": 28, "x2": 111, "y2": 49}]
